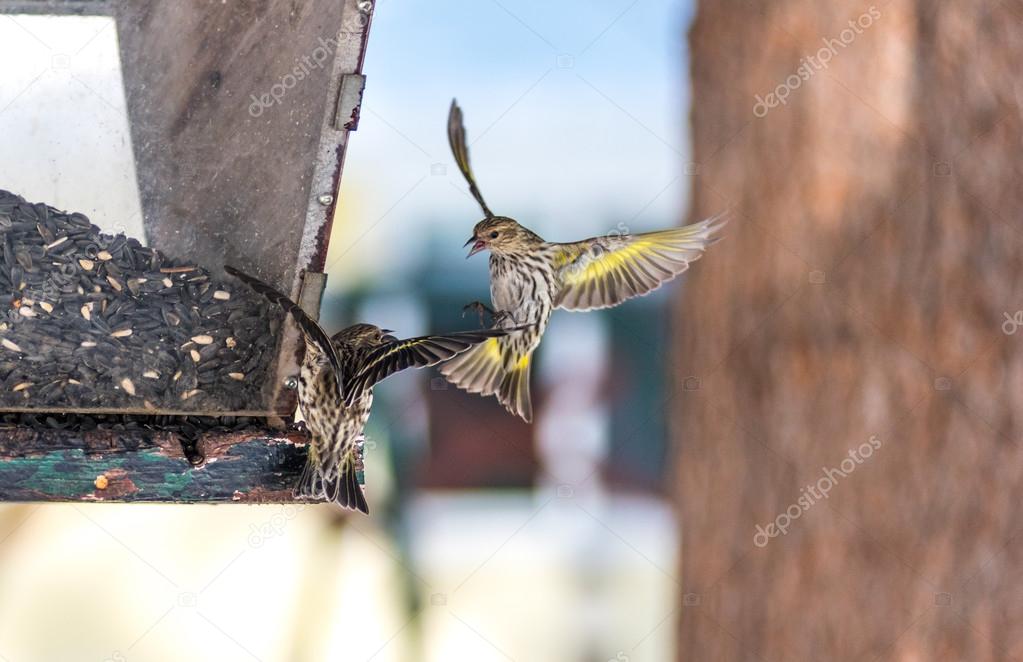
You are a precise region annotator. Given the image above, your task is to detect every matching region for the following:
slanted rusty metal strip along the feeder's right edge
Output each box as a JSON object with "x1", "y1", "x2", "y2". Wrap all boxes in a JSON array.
[{"x1": 272, "y1": 0, "x2": 374, "y2": 414}]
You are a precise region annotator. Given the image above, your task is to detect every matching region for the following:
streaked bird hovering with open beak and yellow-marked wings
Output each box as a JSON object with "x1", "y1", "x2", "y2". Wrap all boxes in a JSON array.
[{"x1": 440, "y1": 101, "x2": 726, "y2": 422}]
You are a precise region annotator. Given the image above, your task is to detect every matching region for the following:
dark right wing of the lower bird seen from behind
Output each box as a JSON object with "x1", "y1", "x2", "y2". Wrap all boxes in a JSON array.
[{"x1": 346, "y1": 328, "x2": 507, "y2": 402}]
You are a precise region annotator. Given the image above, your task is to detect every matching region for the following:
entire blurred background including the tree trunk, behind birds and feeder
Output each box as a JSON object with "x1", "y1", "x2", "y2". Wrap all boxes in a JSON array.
[{"x1": 0, "y1": 0, "x2": 1023, "y2": 662}]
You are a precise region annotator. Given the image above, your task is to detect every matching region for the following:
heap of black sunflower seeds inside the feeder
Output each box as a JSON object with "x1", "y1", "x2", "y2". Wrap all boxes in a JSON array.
[{"x1": 0, "y1": 190, "x2": 281, "y2": 411}]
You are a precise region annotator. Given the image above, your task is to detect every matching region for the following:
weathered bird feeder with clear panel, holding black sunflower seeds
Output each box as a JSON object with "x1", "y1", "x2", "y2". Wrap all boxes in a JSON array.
[{"x1": 0, "y1": 0, "x2": 373, "y2": 500}]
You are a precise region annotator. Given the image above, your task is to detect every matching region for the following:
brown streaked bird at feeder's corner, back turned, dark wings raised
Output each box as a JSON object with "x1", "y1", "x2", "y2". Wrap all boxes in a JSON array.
[{"x1": 224, "y1": 266, "x2": 507, "y2": 514}]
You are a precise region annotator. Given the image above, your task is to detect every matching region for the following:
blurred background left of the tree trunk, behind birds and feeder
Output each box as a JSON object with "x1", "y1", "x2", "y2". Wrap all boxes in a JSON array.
[{"x1": 0, "y1": 0, "x2": 693, "y2": 662}]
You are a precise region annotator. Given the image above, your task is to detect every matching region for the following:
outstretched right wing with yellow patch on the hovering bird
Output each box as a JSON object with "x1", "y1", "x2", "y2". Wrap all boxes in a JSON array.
[{"x1": 554, "y1": 215, "x2": 727, "y2": 310}]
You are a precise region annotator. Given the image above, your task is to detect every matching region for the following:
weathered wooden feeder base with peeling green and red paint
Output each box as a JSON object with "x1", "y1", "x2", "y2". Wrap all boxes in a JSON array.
[{"x1": 0, "y1": 428, "x2": 329, "y2": 503}]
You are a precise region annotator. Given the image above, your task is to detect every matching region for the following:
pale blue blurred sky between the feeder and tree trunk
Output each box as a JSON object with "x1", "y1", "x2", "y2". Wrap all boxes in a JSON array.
[{"x1": 327, "y1": 0, "x2": 692, "y2": 291}]
